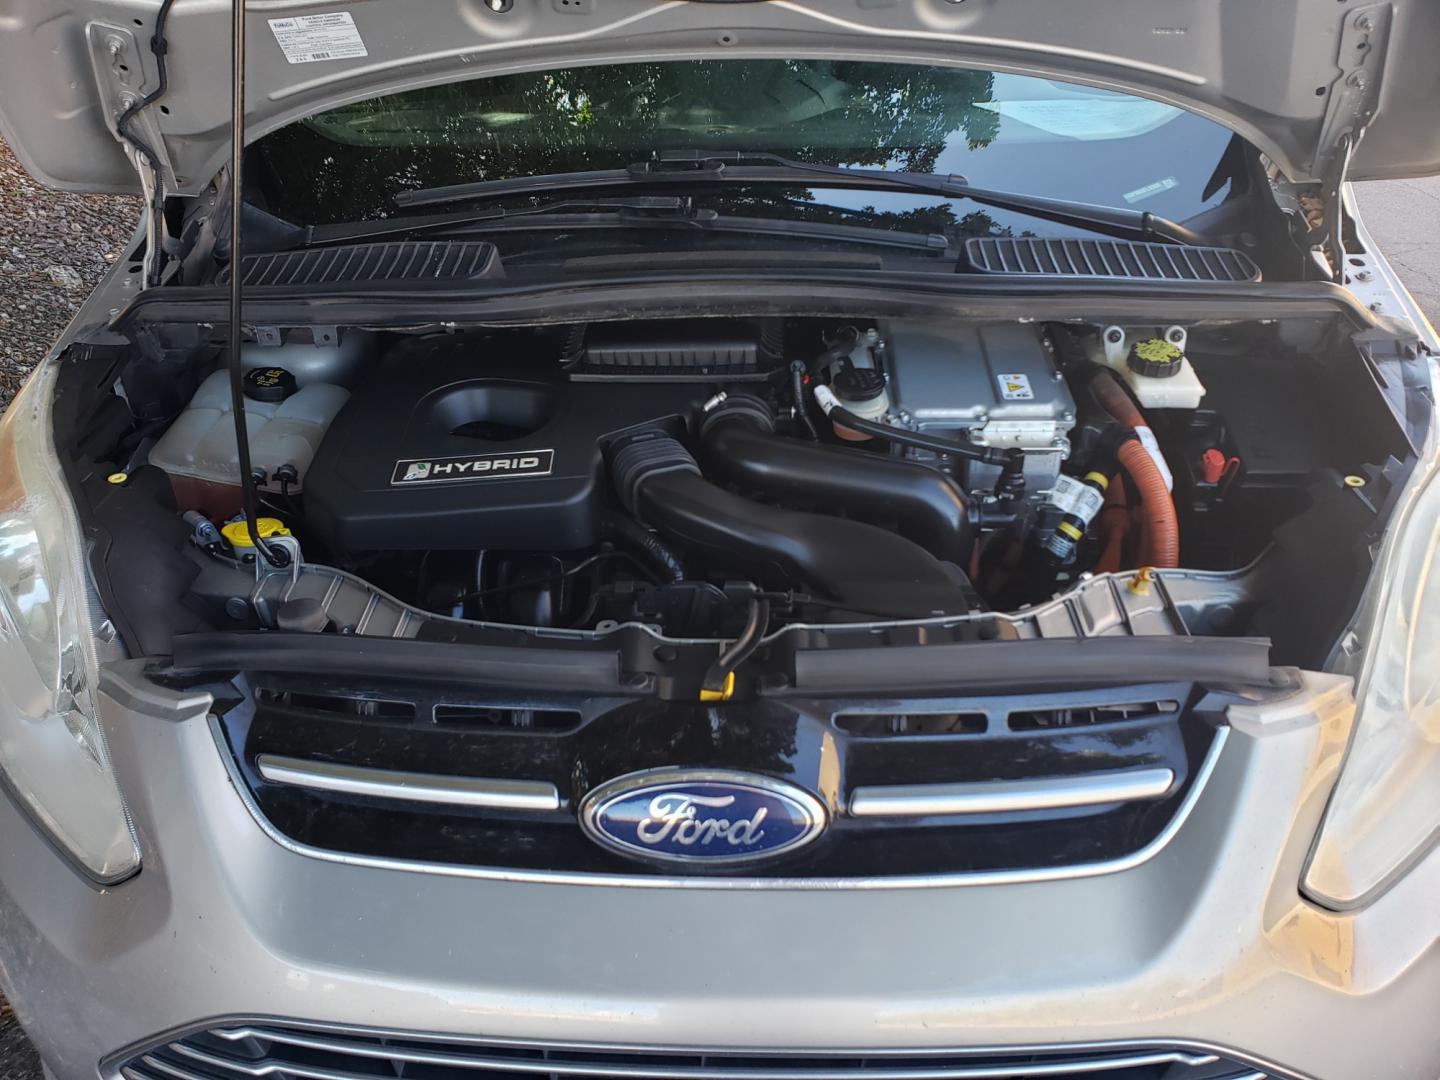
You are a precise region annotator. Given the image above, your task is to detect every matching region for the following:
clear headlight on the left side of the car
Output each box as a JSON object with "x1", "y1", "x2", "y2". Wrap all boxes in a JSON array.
[{"x1": 0, "y1": 363, "x2": 140, "y2": 883}]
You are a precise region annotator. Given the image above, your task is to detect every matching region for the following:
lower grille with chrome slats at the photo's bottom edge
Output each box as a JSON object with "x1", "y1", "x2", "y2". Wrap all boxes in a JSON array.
[{"x1": 118, "y1": 1024, "x2": 1267, "y2": 1080}]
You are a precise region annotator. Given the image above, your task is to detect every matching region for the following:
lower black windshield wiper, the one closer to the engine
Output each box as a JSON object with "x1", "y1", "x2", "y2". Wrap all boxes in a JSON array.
[{"x1": 301, "y1": 196, "x2": 950, "y2": 255}]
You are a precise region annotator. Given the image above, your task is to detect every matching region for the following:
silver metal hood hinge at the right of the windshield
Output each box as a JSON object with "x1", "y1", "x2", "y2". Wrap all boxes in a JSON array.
[{"x1": 1312, "y1": 3, "x2": 1392, "y2": 284}]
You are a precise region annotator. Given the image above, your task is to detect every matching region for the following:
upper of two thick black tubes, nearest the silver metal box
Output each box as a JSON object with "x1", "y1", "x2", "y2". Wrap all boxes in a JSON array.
[{"x1": 701, "y1": 410, "x2": 975, "y2": 566}]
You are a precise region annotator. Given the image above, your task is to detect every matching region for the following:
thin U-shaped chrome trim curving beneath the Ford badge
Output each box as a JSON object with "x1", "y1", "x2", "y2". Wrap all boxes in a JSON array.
[{"x1": 209, "y1": 713, "x2": 1230, "y2": 893}]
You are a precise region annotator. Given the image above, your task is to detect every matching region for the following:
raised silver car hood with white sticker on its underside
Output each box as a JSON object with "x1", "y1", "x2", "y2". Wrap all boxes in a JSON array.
[{"x1": 0, "y1": 0, "x2": 1440, "y2": 194}]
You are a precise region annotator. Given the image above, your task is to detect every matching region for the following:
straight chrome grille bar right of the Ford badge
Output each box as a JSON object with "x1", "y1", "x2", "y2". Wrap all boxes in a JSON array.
[{"x1": 850, "y1": 769, "x2": 1175, "y2": 818}]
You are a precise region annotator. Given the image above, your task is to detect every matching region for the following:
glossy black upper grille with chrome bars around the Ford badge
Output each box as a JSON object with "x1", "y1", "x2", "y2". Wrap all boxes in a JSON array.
[{"x1": 203, "y1": 672, "x2": 1220, "y2": 887}]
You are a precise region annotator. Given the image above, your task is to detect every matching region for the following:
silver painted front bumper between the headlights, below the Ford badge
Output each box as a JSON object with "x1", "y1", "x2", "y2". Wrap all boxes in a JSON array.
[{"x1": 0, "y1": 665, "x2": 1440, "y2": 1080}]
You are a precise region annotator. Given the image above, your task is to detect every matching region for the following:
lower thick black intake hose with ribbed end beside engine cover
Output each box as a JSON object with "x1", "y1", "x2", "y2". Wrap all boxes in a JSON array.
[{"x1": 611, "y1": 436, "x2": 971, "y2": 619}]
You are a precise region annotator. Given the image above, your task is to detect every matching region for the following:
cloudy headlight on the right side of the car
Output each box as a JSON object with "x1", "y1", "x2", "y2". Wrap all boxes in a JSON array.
[{"x1": 1305, "y1": 426, "x2": 1440, "y2": 909}]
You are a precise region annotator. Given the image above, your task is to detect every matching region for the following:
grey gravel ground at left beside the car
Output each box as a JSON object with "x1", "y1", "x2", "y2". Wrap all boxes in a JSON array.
[{"x1": 0, "y1": 141, "x2": 140, "y2": 1080}]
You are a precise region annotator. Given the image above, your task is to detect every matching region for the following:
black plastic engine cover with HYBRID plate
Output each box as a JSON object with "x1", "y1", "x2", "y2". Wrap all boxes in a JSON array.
[{"x1": 305, "y1": 337, "x2": 713, "y2": 553}]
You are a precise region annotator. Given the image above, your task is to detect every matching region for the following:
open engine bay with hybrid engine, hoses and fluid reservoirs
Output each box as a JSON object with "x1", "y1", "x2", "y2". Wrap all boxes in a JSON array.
[{"x1": 56, "y1": 300, "x2": 1405, "y2": 694}]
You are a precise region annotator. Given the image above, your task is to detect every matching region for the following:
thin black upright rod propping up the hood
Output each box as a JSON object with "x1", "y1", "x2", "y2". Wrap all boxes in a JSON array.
[{"x1": 228, "y1": 0, "x2": 289, "y2": 567}]
